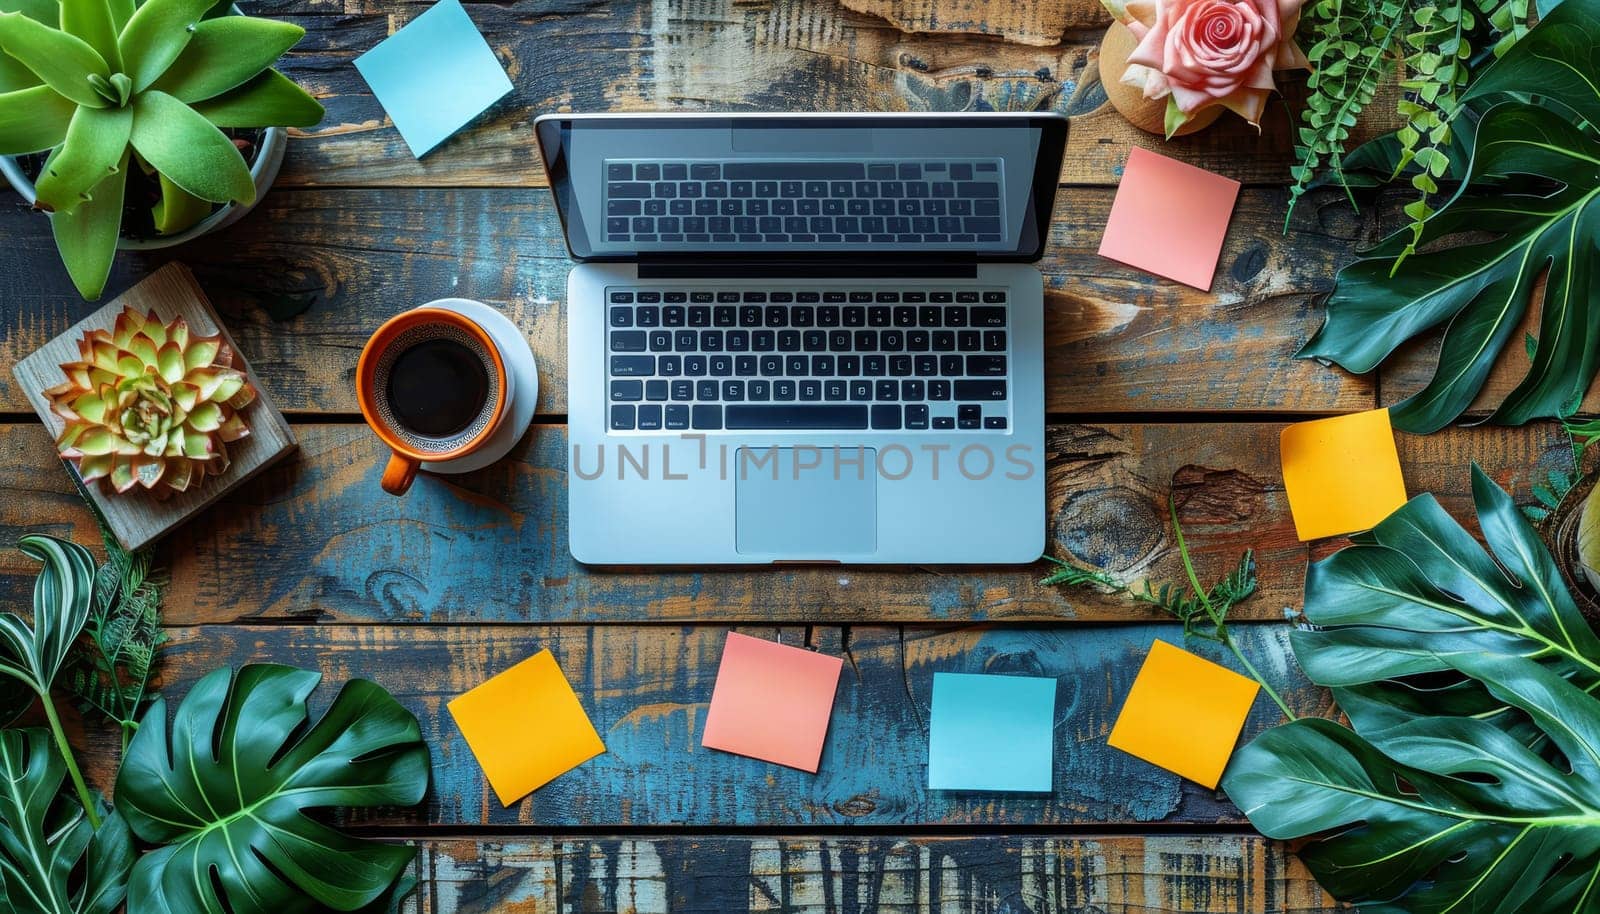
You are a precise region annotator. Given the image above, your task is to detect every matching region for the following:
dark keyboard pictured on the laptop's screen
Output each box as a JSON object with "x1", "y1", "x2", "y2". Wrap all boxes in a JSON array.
[{"x1": 605, "y1": 158, "x2": 1005, "y2": 245}]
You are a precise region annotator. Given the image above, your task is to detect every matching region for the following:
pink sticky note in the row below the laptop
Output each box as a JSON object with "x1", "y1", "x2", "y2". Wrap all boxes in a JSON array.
[{"x1": 701, "y1": 632, "x2": 843, "y2": 775}]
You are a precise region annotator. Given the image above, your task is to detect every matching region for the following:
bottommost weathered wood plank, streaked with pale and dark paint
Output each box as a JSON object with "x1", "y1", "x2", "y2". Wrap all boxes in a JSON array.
[{"x1": 402, "y1": 836, "x2": 1338, "y2": 914}]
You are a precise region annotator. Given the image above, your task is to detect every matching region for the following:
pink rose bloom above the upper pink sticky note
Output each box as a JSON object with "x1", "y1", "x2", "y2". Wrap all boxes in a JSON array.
[{"x1": 1106, "y1": 0, "x2": 1307, "y2": 123}]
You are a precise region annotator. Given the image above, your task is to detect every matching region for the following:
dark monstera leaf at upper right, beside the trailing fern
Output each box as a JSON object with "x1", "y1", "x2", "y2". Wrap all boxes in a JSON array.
[{"x1": 1299, "y1": 0, "x2": 1600, "y2": 434}]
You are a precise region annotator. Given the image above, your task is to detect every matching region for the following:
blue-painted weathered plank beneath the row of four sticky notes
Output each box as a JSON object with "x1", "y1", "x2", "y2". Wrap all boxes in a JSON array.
[{"x1": 75, "y1": 623, "x2": 1328, "y2": 831}]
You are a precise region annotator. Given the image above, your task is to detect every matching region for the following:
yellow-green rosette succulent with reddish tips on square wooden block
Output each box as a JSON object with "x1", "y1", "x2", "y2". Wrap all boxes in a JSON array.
[{"x1": 45, "y1": 309, "x2": 256, "y2": 498}]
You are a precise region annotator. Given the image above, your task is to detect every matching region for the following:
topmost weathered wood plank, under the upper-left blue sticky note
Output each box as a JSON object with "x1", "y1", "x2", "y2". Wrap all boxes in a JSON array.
[{"x1": 246, "y1": 0, "x2": 1293, "y2": 187}]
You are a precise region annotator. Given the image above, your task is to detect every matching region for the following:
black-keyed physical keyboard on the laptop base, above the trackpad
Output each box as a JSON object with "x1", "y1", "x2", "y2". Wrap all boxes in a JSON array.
[{"x1": 606, "y1": 288, "x2": 1010, "y2": 431}]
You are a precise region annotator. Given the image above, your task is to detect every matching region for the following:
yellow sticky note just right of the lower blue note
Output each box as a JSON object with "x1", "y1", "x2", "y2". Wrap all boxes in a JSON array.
[{"x1": 1109, "y1": 640, "x2": 1259, "y2": 789}]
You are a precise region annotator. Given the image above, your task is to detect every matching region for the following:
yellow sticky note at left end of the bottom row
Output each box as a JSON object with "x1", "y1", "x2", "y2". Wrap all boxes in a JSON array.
[{"x1": 450, "y1": 650, "x2": 605, "y2": 807}]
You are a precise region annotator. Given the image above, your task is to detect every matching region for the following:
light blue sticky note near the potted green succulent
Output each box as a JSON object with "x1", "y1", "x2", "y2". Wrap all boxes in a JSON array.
[{"x1": 355, "y1": 0, "x2": 510, "y2": 158}]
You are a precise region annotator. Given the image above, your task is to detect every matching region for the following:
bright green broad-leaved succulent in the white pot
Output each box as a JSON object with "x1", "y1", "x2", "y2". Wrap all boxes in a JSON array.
[{"x1": 0, "y1": 0, "x2": 323, "y2": 299}]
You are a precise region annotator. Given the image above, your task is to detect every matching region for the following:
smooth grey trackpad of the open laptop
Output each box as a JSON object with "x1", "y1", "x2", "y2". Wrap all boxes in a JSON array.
[{"x1": 733, "y1": 448, "x2": 878, "y2": 559}]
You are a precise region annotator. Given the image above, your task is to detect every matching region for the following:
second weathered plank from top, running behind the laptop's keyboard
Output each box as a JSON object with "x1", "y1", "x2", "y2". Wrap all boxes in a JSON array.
[{"x1": 0, "y1": 187, "x2": 1374, "y2": 415}]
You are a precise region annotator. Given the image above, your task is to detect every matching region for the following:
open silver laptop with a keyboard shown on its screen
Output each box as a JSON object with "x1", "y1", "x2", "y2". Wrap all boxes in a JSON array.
[{"x1": 534, "y1": 114, "x2": 1067, "y2": 565}]
